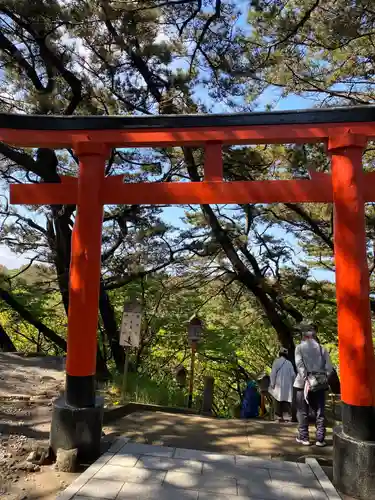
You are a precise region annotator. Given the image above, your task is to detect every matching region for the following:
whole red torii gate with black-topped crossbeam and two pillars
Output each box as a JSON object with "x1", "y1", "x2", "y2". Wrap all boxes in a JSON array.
[{"x1": 0, "y1": 106, "x2": 375, "y2": 493}]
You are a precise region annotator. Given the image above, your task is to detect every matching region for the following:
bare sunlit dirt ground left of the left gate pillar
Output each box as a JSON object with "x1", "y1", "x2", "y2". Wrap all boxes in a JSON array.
[{"x1": 0, "y1": 353, "x2": 77, "y2": 500}]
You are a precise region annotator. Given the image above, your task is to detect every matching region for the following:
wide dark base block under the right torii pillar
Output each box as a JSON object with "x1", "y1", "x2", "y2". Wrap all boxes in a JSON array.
[{"x1": 333, "y1": 422, "x2": 375, "y2": 500}]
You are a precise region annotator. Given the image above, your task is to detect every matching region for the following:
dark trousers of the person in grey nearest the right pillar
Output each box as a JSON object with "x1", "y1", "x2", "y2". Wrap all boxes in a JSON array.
[{"x1": 296, "y1": 389, "x2": 326, "y2": 441}]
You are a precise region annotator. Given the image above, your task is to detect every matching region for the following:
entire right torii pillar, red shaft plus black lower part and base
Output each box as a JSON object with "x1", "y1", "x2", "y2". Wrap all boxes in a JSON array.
[{"x1": 329, "y1": 134, "x2": 375, "y2": 498}]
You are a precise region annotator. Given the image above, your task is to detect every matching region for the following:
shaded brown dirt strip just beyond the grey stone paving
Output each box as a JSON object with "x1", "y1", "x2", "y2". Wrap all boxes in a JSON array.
[{"x1": 104, "y1": 412, "x2": 332, "y2": 462}]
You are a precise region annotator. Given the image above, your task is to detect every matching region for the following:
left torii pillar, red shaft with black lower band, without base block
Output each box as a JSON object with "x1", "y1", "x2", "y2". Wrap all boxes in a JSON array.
[{"x1": 66, "y1": 141, "x2": 108, "y2": 408}]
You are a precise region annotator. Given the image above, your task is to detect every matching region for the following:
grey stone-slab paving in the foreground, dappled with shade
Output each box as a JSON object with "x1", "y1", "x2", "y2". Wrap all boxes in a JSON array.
[{"x1": 58, "y1": 438, "x2": 340, "y2": 500}]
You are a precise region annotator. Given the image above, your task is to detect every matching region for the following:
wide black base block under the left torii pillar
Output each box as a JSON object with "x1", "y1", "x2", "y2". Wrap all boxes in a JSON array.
[{"x1": 50, "y1": 397, "x2": 104, "y2": 462}]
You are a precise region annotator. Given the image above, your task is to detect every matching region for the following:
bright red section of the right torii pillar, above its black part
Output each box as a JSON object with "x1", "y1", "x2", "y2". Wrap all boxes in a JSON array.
[{"x1": 329, "y1": 135, "x2": 375, "y2": 426}]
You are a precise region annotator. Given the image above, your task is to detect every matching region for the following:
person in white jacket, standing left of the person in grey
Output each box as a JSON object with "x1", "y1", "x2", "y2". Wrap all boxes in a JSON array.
[{"x1": 269, "y1": 347, "x2": 296, "y2": 422}]
